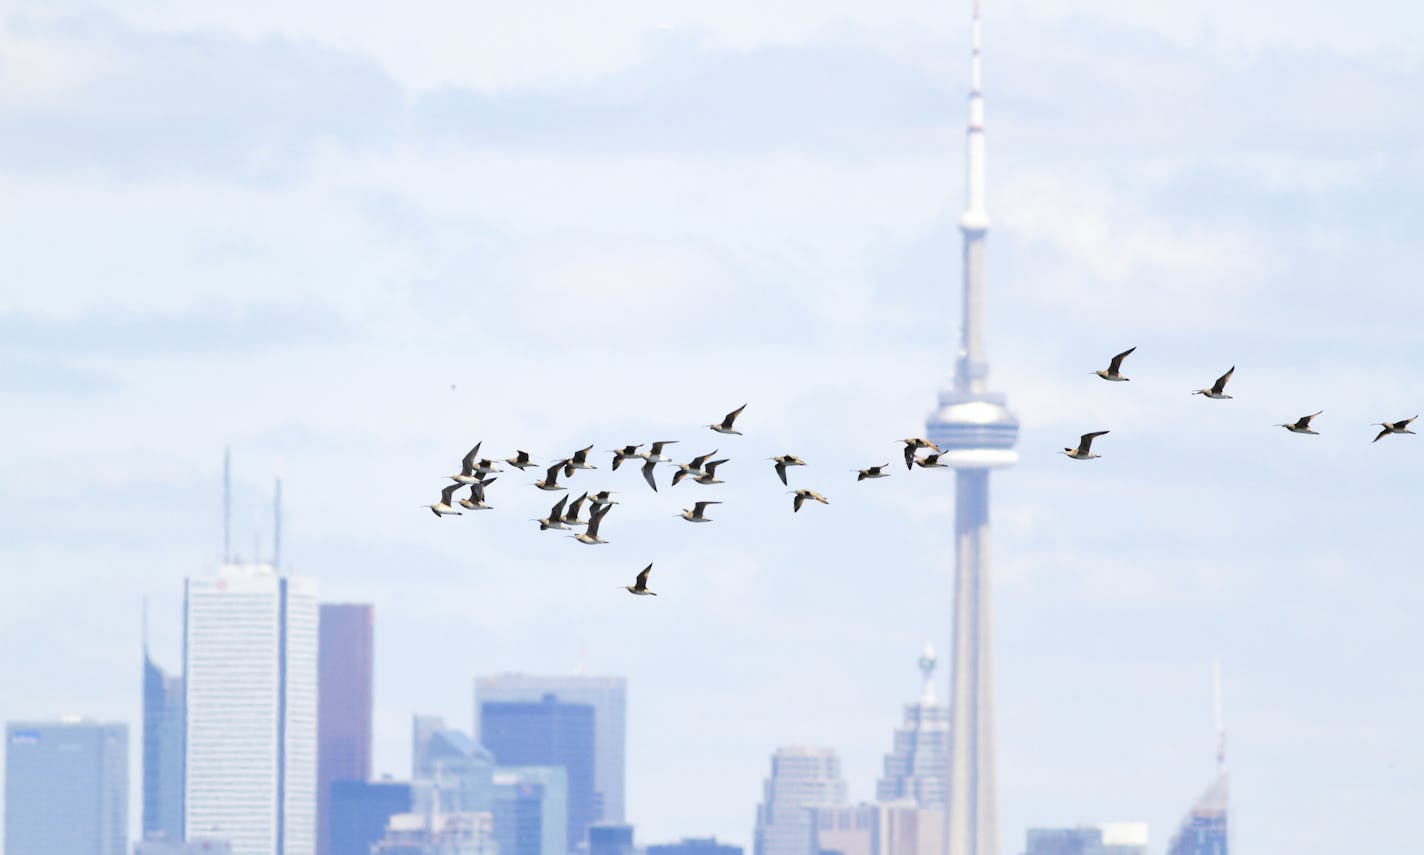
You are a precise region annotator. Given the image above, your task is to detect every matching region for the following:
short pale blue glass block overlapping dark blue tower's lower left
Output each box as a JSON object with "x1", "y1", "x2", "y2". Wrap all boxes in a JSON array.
[{"x1": 491, "y1": 767, "x2": 568, "y2": 855}]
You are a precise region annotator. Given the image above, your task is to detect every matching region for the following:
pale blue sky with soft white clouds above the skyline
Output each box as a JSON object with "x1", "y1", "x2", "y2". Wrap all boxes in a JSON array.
[{"x1": 0, "y1": 0, "x2": 1424, "y2": 854}]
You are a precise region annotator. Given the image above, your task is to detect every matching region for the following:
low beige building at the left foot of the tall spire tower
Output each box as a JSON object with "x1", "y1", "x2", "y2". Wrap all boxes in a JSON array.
[{"x1": 813, "y1": 799, "x2": 944, "y2": 855}]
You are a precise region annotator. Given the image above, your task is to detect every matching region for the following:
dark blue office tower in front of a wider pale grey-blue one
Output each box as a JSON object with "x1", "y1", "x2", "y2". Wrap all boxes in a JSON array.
[{"x1": 480, "y1": 694, "x2": 597, "y2": 851}]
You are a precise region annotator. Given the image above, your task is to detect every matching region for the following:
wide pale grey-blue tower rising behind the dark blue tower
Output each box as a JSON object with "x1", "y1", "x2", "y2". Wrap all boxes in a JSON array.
[{"x1": 474, "y1": 674, "x2": 628, "y2": 820}]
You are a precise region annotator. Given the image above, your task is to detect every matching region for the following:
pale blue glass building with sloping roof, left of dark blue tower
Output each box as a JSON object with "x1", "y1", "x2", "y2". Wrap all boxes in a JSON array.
[{"x1": 412, "y1": 715, "x2": 494, "y2": 814}]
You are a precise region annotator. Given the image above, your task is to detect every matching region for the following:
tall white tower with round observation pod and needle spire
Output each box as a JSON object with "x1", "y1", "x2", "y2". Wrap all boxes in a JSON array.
[{"x1": 927, "y1": 6, "x2": 1018, "y2": 855}]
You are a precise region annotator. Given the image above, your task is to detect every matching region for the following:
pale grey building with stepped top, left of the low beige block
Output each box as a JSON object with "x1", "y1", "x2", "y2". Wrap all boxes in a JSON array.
[{"x1": 753, "y1": 748, "x2": 846, "y2": 855}]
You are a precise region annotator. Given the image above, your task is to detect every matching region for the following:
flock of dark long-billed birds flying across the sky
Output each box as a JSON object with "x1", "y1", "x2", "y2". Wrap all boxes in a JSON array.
[{"x1": 422, "y1": 348, "x2": 1418, "y2": 596}]
